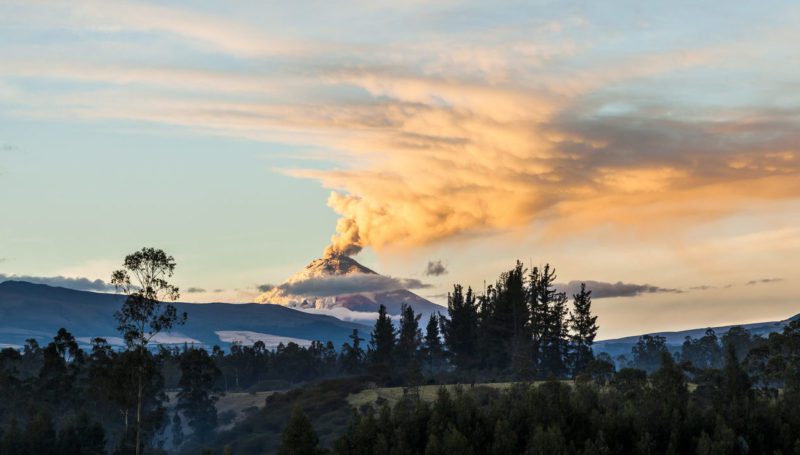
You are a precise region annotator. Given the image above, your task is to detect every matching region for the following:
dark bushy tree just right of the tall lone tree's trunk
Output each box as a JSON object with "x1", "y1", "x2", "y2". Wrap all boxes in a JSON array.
[{"x1": 175, "y1": 349, "x2": 221, "y2": 441}]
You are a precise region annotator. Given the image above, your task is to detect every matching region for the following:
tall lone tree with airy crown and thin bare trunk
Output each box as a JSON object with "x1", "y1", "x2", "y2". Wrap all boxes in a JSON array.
[{"x1": 111, "y1": 248, "x2": 186, "y2": 455}]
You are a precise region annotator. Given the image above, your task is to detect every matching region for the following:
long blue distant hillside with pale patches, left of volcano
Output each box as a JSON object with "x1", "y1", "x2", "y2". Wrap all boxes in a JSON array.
[{"x1": 0, "y1": 281, "x2": 370, "y2": 348}]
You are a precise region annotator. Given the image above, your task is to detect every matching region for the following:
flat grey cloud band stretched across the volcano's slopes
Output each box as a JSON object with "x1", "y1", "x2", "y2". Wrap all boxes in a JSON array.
[{"x1": 278, "y1": 274, "x2": 431, "y2": 297}]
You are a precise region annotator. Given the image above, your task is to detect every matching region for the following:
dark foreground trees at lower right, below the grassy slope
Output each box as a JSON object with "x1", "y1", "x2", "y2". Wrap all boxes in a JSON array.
[{"x1": 279, "y1": 321, "x2": 800, "y2": 455}]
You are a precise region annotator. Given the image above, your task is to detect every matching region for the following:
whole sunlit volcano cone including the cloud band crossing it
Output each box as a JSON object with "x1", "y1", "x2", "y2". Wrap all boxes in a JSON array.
[{"x1": 256, "y1": 256, "x2": 444, "y2": 314}]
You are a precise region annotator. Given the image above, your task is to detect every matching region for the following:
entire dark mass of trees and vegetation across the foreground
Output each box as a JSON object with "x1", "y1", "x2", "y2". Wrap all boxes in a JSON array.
[{"x1": 0, "y1": 249, "x2": 800, "y2": 455}]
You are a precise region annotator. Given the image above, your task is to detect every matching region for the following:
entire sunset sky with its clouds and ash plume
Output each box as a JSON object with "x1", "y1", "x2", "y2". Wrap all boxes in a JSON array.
[{"x1": 0, "y1": 0, "x2": 800, "y2": 336}]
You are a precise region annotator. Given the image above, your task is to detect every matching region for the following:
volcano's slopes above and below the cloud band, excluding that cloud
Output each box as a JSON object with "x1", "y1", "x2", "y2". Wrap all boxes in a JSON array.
[{"x1": 256, "y1": 256, "x2": 446, "y2": 315}]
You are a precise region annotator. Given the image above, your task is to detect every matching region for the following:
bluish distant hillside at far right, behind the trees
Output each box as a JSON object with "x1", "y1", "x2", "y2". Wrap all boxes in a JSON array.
[{"x1": 594, "y1": 314, "x2": 800, "y2": 357}]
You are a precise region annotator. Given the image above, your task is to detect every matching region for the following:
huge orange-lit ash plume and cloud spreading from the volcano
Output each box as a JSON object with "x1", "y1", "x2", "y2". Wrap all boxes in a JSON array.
[{"x1": 6, "y1": 2, "x2": 800, "y2": 255}]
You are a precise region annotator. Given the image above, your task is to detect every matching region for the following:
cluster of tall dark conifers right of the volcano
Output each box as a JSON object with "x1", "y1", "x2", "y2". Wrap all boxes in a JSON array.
[{"x1": 332, "y1": 263, "x2": 598, "y2": 385}]
